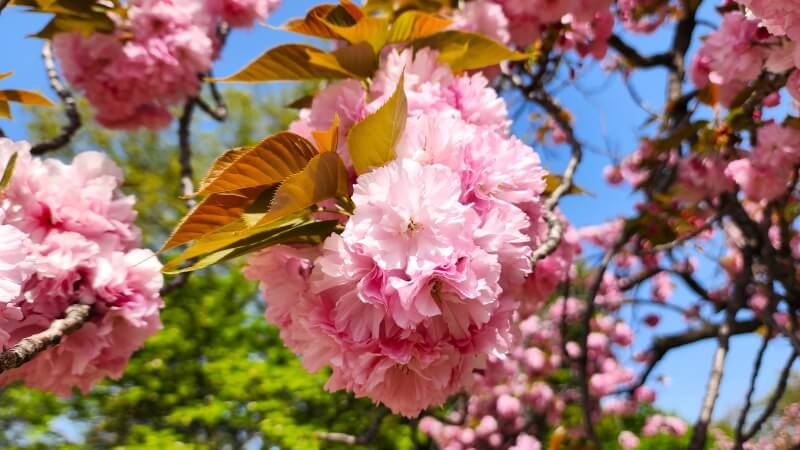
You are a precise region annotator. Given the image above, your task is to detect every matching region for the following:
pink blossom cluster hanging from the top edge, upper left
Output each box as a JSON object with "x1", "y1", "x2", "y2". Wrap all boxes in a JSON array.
[{"x1": 53, "y1": 0, "x2": 279, "y2": 129}]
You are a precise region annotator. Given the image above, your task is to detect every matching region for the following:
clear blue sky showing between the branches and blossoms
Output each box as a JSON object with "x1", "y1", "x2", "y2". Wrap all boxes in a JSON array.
[{"x1": 0, "y1": 0, "x2": 788, "y2": 421}]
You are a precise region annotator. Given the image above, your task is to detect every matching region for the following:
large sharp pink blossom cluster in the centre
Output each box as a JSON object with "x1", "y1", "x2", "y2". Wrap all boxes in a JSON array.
[{"x1": 246, "y1": 49, "x2": 569, "y2": 416}]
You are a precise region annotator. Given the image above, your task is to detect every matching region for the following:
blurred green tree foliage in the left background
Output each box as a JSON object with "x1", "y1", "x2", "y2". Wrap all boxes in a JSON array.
[{"x1": 0, "y1": 87, "x2": 411, "y2": 450}]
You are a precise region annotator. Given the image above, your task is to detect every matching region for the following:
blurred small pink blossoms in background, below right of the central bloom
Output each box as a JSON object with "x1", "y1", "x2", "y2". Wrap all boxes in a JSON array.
[{"x1": 420, "y1": 227, "x2": 687, "y2": 450}]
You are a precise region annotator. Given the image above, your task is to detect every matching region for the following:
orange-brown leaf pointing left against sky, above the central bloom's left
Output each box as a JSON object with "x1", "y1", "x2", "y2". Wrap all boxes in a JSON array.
[{"x1": 214, "y1": 44, "x2": 351, "y2": 83}]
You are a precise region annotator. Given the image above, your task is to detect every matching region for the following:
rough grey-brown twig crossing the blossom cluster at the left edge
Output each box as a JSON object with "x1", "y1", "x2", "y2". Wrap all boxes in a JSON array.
[{"x1": 0, "y1": 305, "x2": 92, "y2": 373}]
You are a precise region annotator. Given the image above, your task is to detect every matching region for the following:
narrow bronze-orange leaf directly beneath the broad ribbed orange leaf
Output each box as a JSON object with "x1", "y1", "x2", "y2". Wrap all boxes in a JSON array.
[{"x1": 160, "y1": 186, "x2": 268, "y2": 252}]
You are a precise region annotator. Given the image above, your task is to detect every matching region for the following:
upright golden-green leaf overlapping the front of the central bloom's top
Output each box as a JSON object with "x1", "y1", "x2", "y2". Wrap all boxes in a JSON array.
[{"x1": 347, "y1": 76, "x2": 408, "y2": 175}]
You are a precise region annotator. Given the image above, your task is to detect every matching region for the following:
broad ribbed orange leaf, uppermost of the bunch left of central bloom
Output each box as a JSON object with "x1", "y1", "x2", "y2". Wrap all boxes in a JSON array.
[{"x1": 198, "y1": 132, "x2": 317, "y2": 194}]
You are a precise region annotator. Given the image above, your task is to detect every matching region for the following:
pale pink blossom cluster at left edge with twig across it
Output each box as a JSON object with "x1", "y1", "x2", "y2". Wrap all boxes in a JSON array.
[{"x1": 0, "y1": 139, "x2": 163, "y2": 396}]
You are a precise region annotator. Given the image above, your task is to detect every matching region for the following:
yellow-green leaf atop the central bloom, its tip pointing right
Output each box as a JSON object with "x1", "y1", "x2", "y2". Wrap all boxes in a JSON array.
[{"x1": 412, "y1": 30, "x2": 529, "y2": 72}]
